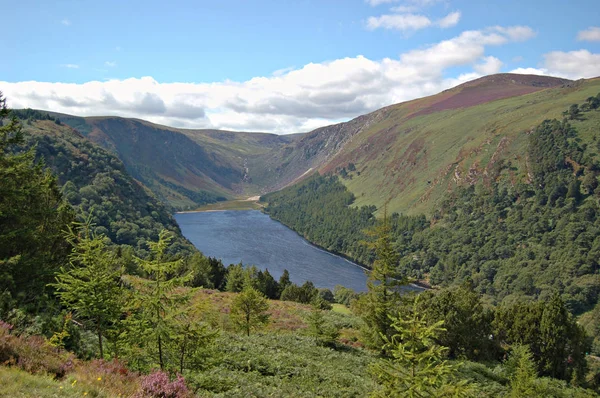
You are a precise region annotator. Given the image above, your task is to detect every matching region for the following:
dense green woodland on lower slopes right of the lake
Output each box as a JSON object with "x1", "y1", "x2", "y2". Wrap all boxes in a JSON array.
[{"x1": 262, "y1": 97, "x2": 600, "y2": 346}]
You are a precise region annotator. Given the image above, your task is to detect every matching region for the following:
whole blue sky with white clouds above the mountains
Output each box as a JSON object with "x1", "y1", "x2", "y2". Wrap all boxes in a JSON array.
[{"x1": 0, "y1": 0, "x2": 600, "y2": 134}]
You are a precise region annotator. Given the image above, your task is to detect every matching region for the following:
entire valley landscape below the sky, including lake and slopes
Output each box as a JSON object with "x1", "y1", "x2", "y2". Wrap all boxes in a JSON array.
[{"x1": 0, "y1": 74, "x2": 600, "y2": 397}]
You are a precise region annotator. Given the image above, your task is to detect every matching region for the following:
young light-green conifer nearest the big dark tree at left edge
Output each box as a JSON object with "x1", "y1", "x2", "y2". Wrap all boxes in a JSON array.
[{"x1": 52, "y1": 223, "x2": 123, "y2": 358}]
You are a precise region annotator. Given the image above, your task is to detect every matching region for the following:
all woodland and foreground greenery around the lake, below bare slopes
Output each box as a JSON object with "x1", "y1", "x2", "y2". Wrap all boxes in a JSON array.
[{"x1": 0, "y1": 92, "x2": 600, "y2": 397}]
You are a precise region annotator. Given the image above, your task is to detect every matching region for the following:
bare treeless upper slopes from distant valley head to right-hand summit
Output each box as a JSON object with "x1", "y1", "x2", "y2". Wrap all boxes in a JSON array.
[{"x1": 18, "y1": 74, "x2": 600, "y2": 214}]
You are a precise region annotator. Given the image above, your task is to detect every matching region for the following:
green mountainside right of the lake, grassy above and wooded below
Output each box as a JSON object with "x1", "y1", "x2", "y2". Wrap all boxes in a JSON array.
[{"x1": 261, "y1": 79, "x2": 600, "y2": 314}]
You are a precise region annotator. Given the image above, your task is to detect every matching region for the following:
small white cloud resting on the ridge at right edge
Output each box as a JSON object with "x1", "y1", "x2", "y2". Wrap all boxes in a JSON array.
[{"x1": 543, "y1": 50, "x2": 600, "y2": 79}]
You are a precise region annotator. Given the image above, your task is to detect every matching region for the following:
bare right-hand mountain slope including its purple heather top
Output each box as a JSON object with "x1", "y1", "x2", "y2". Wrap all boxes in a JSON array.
[{"x1": 278, "y1": 74, "x2": 600, "y2": 214}]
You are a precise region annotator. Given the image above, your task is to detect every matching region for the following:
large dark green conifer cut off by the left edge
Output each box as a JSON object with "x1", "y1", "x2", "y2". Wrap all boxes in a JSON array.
[{"x1": 0, "y1": 92, "x2": 74, "y2": 304}]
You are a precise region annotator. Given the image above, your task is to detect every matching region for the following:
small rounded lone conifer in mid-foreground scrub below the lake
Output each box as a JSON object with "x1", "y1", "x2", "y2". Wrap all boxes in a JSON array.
[{"x1": 230, "y1": 285, "x2": 269, "y2": 336}]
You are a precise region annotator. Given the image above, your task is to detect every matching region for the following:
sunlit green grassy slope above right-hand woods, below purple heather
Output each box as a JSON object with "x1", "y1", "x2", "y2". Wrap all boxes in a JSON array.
[{"x1": 322, "y1": 79, "x2": 600, "y2": 214}]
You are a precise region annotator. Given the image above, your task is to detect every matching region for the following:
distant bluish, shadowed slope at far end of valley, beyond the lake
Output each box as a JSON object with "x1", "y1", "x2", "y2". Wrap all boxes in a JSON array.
[{"x1": 54, "y1": 114, "x2": 294, "y2": 209}]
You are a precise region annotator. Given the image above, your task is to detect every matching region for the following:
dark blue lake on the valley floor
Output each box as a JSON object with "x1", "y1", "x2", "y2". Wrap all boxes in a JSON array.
[{"x1": 175, "y1": 210, "x2": 367, "y2": 291}]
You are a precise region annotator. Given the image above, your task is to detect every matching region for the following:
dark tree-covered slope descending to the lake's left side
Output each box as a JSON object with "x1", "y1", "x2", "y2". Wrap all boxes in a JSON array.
[{"x1": 17, "y1": 116, "x2": 194, "y2": 254}]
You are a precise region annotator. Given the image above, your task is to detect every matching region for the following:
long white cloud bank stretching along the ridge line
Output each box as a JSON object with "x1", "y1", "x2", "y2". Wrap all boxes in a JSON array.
[{"x1": 0, "y1": 28, "x2": 544, "y2": 133}]
